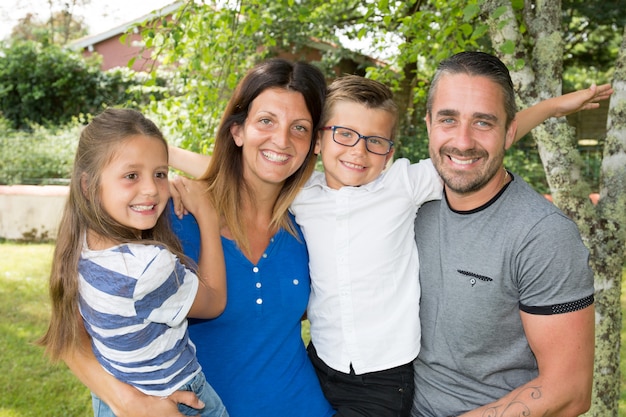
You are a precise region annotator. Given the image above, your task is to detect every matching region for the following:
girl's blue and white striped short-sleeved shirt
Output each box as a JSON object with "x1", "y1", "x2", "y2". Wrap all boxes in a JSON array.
[{"x1": 78, "y1": 240, "x2": 201, "y2": 396}]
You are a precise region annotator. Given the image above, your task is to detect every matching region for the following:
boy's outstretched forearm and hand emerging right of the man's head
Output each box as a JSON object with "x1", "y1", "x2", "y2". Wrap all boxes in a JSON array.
[{"x1": 515, "y1": 84, "x2": 613, "y2": 141}]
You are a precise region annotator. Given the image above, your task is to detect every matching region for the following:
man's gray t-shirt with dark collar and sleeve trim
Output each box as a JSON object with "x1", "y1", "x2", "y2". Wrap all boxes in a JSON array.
[{"x1": 412, "y1": 172, "x2": 593, "y2": 417}]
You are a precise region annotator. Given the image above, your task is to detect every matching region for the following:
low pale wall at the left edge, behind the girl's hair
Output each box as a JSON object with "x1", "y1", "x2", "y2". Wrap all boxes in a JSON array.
[{"x1": 0, "y1": 185, "x2": 69, "y2": 242}]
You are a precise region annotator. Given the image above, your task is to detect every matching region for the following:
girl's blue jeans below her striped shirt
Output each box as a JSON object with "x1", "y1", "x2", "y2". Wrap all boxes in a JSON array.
[{"x1": 91, "y1": 372, "x2": 228, "y2": 417}]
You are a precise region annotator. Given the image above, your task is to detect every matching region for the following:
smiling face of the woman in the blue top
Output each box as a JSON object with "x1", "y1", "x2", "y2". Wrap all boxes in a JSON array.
[{"x1": 231, "y1": 88, "x2": 313, "y2": 191}]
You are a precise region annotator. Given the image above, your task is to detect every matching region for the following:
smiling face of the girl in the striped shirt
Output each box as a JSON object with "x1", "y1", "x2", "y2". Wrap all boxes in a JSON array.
[{"x1": 100, "y1": 135, "x2": 170, "y2": 234}]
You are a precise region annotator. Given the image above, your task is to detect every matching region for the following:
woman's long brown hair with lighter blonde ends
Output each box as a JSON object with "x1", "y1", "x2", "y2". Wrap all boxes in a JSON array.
[{"x1": 202, "y1": 59, "x2": 326, "y2": 252}]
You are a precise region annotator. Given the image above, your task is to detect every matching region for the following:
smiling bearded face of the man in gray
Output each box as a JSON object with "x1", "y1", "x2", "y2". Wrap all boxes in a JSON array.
[{"x1": 426, "y1": 74, "x2": 516, "y2": 209}]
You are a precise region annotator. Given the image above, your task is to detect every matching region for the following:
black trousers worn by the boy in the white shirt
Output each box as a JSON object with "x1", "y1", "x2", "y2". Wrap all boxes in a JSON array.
[{"x1": 307, "y1": 343, "x2": 415, "y2": 417}]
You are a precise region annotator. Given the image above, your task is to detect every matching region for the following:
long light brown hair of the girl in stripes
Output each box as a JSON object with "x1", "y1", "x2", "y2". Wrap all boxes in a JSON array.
[{"x1": 37, "y1": 109, "x2": 185, "y2": 360}]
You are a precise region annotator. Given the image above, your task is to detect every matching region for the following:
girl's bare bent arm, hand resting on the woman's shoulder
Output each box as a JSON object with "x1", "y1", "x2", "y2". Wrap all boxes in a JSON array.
[{"x1": 172, "y1": 177, "x2": 226, "y2": 318}]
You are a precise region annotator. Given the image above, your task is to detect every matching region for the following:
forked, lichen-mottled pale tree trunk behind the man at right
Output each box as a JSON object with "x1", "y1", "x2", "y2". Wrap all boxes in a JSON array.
[{"x1": 483, "y1": 0, "x2": 626, "y2": 417}]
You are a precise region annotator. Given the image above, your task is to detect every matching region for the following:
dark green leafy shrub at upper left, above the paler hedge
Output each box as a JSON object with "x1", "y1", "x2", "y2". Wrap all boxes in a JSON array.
[{"x1": 0, "y1": 41, "x2": 167, "y2": 130}]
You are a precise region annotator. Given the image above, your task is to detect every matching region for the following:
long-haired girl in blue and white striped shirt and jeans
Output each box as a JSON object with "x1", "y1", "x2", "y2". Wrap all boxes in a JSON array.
[{"x1": 39, "y1": 109, "x2": 228, "y2": 417}]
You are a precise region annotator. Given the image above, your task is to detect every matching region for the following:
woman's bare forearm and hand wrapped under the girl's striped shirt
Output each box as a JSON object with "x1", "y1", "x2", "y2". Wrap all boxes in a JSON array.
[{"x1": 62, "y1": 316, "x2": 204, "y2": 417}]
